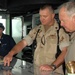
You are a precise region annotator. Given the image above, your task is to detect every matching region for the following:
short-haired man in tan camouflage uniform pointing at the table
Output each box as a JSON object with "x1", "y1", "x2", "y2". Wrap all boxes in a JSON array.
[{"x1": 4, "y1": 5, "x2": 69, "y2": 75}]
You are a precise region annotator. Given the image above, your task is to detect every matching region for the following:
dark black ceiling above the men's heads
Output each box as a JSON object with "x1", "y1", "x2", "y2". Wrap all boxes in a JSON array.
[{"x1": 0, "y1": 0, "x2": 69, "y2": 15}]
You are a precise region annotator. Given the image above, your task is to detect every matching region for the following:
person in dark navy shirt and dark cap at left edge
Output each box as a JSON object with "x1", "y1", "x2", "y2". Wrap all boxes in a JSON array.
[{"x1": 0, "y1": 23, "x2": 16, "y2": 67}]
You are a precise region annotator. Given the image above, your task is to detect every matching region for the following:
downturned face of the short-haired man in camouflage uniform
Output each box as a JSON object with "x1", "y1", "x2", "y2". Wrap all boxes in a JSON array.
[{"x1": 39, "y1": 8, "x2": 54, "y2": 25}]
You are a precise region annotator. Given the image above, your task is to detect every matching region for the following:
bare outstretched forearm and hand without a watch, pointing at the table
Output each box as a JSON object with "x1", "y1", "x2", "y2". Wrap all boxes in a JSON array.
[{"x1": 3, "y1": 39, "x2": 27, "y2": 66}]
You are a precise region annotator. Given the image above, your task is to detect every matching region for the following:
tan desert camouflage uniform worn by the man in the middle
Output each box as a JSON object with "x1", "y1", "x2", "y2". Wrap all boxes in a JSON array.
[{"x1": 25, "y1": 21, "x2": 69, "y2": 75}]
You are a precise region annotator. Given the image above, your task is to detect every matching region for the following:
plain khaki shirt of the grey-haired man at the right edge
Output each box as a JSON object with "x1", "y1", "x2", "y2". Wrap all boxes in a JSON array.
[{"x1": 65, "y1": 32, "x2": 75, "y2": 63}]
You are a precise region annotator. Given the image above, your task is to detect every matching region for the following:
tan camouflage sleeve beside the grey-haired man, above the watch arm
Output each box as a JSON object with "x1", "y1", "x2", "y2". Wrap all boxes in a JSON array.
[{"x1": 59, "y1": 28, "x2": 69, "y2": 50}]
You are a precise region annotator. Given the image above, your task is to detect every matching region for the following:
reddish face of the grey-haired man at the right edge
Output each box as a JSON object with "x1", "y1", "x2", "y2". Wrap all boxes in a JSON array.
[{"x1": 59, "y1": 8, "x2": 75, "y2": 32}]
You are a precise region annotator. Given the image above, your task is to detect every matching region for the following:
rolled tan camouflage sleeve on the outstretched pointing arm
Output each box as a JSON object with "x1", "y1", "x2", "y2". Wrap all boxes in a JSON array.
[{"x1": 24, "y1": 28, "x2": 37, "y2": 46}]
